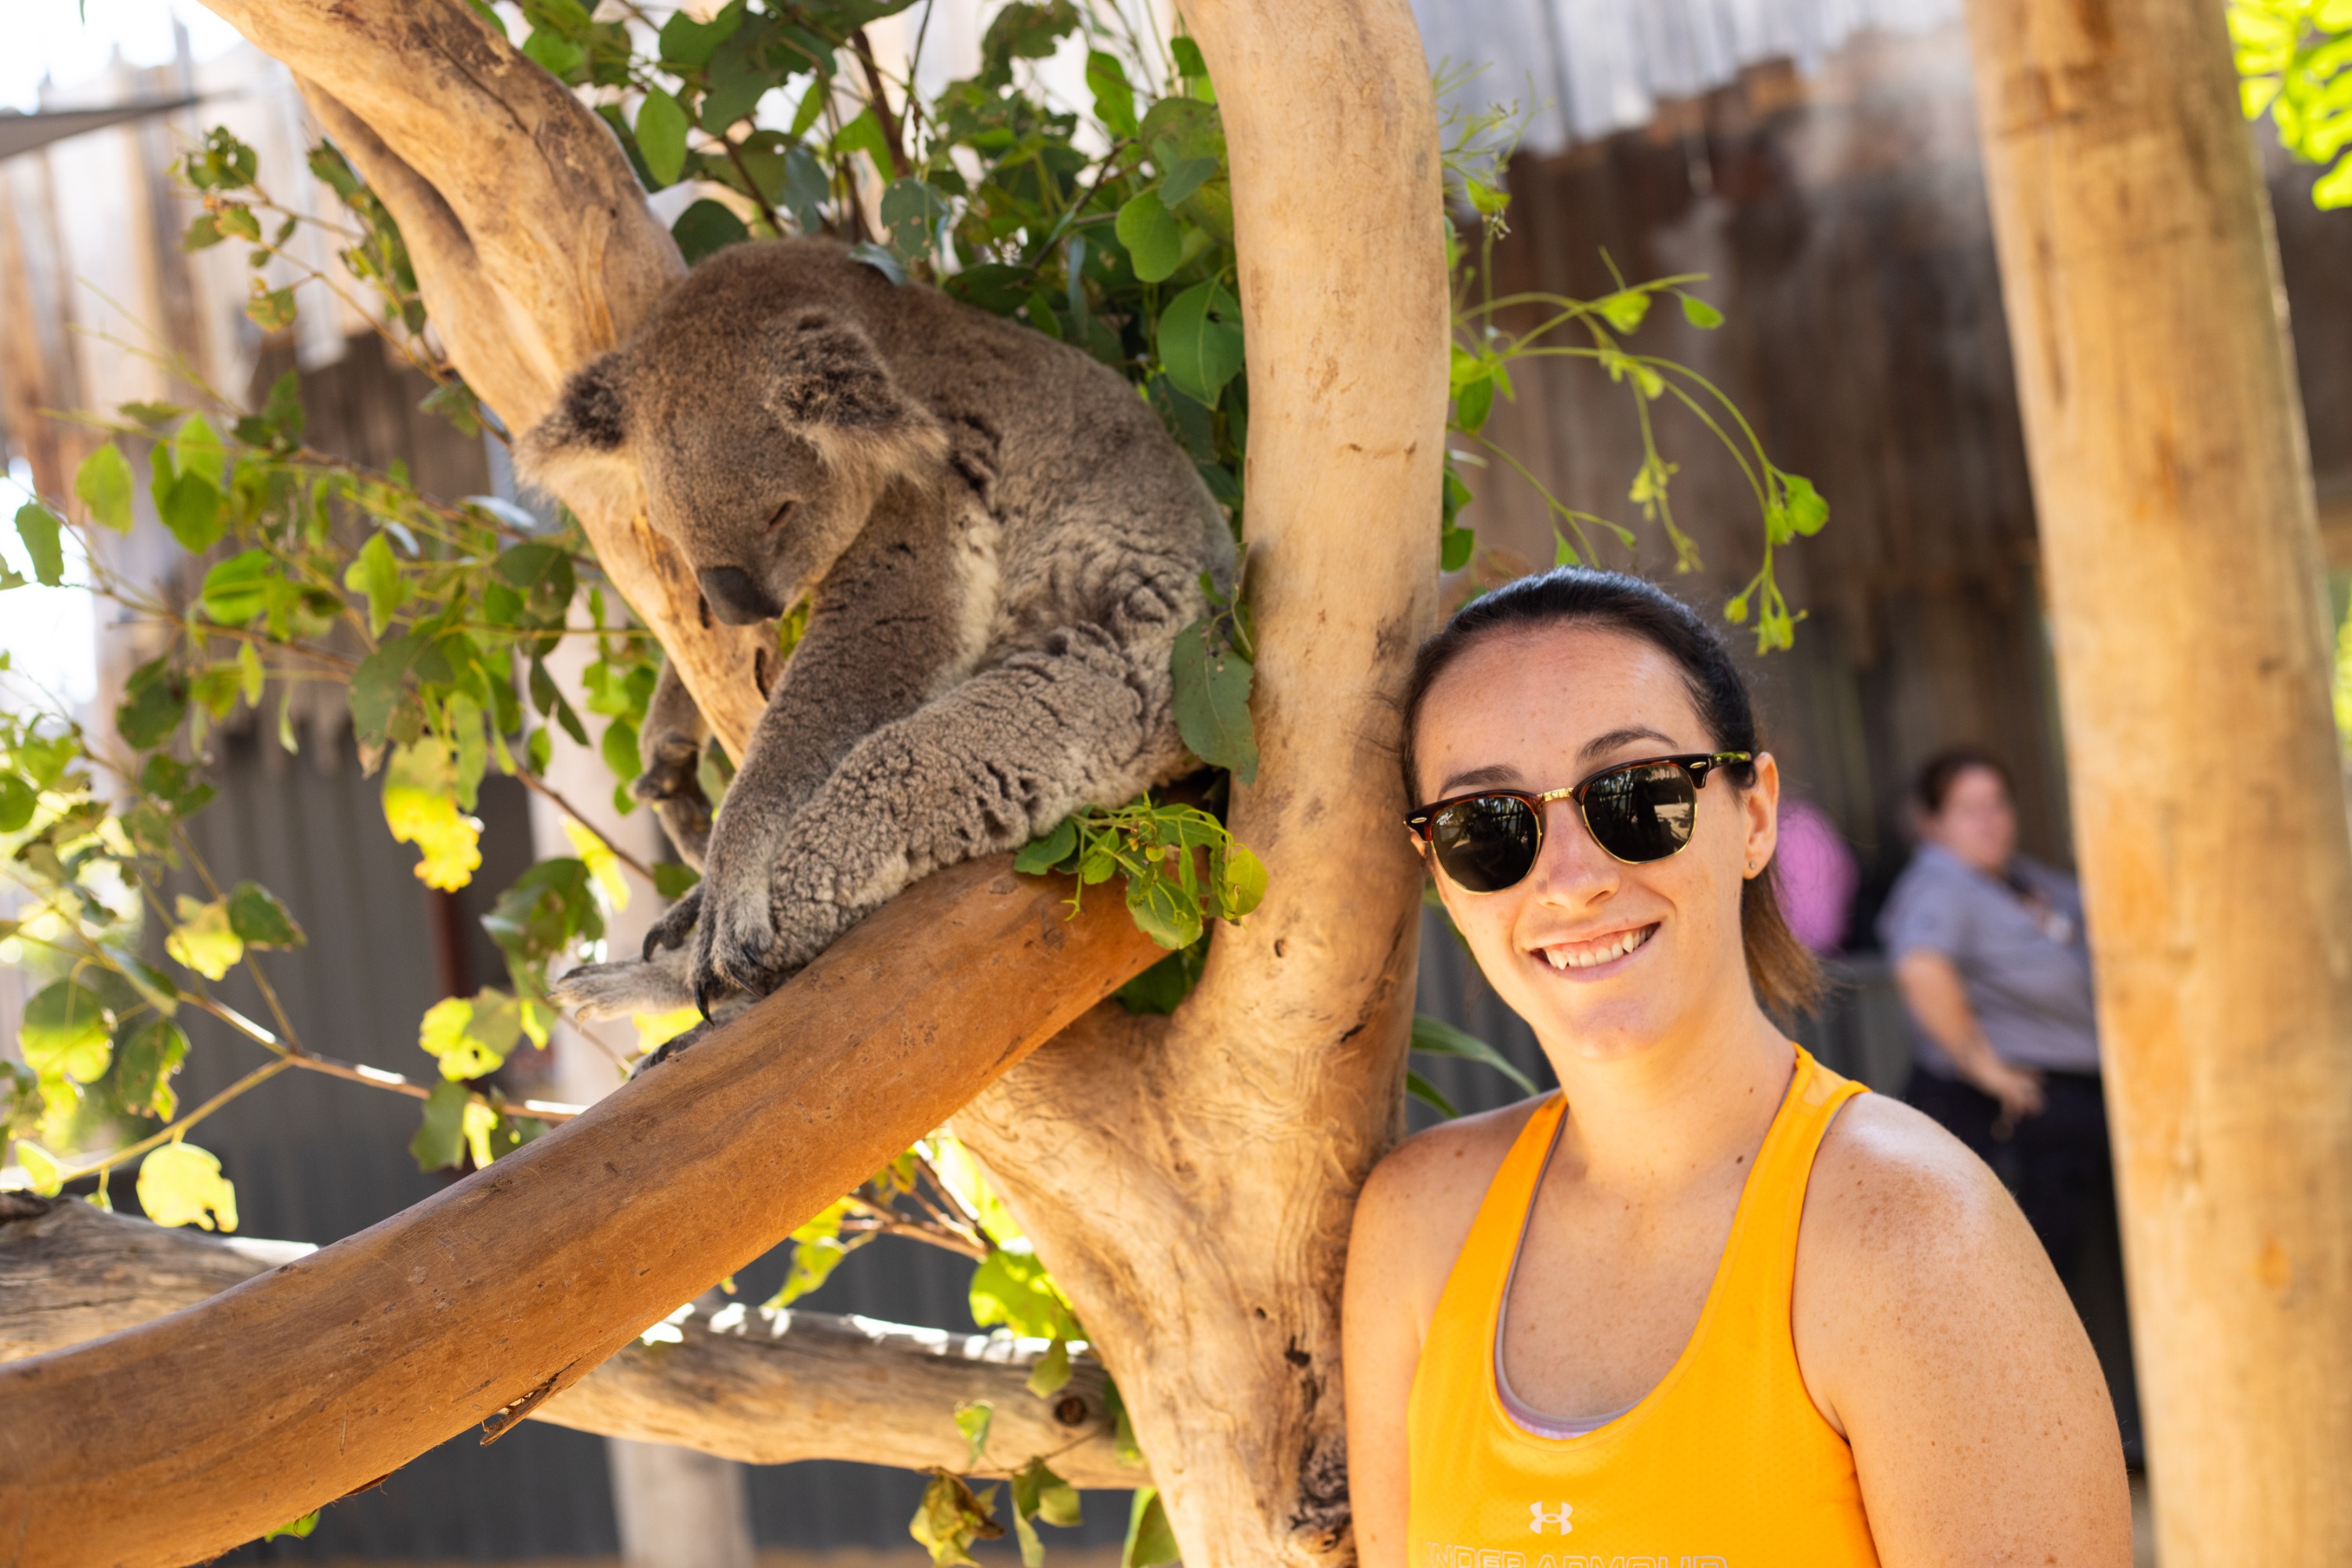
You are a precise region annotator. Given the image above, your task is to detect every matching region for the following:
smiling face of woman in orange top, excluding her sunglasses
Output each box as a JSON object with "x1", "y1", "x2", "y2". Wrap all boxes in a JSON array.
[{"x1": 1416, "y1": 628, "x2": 1780, "y2": 1060}]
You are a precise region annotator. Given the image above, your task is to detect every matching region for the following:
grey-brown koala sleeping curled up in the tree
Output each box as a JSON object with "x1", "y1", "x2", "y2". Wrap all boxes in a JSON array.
[{"x1": 517, "y1": 240, "x2": 1232, "y2": 1018}]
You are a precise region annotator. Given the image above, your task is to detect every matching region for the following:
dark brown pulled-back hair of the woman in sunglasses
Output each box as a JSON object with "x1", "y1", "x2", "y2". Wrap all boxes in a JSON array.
[{"x1": 1402, "y1": 567, "x2": 1823, "y2": 1018}]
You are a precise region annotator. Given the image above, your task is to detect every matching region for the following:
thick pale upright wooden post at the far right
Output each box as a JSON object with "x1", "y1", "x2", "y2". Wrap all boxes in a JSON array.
[{"x1": 1969, "y1": 0, "x2": 2352, "y2": 1568}]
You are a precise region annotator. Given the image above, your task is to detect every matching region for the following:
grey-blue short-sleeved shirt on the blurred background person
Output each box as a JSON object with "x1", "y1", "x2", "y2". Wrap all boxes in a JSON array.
[{"x1": 1879, "y1": 844, "x2": 2098, "y2": 1079}]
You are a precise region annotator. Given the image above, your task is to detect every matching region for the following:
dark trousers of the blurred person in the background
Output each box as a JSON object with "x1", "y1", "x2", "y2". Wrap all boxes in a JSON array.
[{"x1": 1903, "y1": 1069, "x2": 2114, "y2": 1279}]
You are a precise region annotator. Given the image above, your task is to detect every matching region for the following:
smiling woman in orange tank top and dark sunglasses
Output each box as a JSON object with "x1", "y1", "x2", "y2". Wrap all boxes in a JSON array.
[{"x1": 1345, "y1": 572, "x2": 2131, "y2": 1568}]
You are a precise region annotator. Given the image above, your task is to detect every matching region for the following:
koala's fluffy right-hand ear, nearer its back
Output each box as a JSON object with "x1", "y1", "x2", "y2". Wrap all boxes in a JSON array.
[{"x1": 767, "y1": 310, "x2": 948, "y2": 468}]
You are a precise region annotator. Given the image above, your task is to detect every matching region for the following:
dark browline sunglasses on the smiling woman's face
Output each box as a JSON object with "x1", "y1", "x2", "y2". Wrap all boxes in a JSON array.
[{"x1": 1404, "y1": 753, "x2": 1755, "y2": 893}]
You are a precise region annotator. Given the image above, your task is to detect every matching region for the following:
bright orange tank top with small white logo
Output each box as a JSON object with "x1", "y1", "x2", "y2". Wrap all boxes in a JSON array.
[{"x1": 1406, "y1": 1048, "x2": 1879, "y2": 1568}]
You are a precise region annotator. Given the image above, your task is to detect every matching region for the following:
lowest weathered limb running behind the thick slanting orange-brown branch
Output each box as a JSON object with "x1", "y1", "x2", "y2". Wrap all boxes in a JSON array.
[{"x1": 0, "y1": 1194, "x2": 1150, "y2": 1488}]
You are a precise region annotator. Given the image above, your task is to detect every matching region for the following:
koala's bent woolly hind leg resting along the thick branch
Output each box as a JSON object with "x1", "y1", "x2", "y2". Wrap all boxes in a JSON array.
[{"x1": 694, "y1": 628, "x2": 1181, "y2": 989}]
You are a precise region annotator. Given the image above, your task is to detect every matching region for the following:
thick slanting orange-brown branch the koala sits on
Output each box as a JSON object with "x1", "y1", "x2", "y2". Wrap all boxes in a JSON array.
[{"x1": 0, "y1": 855, "x2": 1160, "y2": 1568}]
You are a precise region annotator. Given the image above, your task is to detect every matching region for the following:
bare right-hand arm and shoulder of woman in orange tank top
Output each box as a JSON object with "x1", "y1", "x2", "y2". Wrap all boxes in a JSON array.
[{"x1": 1792, "y1": 1095, "x2": 2131, "y2": 1568}]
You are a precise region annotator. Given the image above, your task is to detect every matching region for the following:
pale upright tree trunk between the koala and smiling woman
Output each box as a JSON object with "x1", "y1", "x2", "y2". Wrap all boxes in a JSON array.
[{"x1": 955, "y1": 0, "x2": 1446, "y2": 1568}]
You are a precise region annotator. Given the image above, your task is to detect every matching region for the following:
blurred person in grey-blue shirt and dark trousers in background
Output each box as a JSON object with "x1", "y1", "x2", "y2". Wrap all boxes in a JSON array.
[{"x1": 1879, "y1": 748, "x2": 2110, "y2": 1272}]
